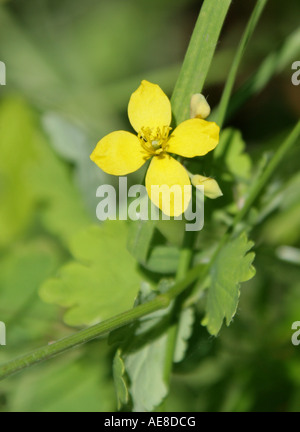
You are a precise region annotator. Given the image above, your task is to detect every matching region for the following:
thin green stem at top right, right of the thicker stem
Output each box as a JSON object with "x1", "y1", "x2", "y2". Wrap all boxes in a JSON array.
[{"x1": 217, "y1": 0, "x2": 268, "y2": 128}]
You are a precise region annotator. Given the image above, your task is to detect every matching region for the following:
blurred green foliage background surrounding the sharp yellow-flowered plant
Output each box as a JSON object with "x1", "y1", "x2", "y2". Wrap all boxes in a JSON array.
[{"x1": 0, "y1": 0, "x2": 300, "y2": 412}]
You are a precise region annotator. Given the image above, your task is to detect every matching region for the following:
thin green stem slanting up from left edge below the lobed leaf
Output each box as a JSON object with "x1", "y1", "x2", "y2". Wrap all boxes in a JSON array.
[{"x1": 0, "y1": 265, "x2": 202, "y2": 380}]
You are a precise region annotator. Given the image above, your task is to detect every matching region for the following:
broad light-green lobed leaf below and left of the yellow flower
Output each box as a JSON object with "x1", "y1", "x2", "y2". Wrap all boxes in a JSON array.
[{"x1": 40, "y1": 221, "x2": 143, "y2": 326}]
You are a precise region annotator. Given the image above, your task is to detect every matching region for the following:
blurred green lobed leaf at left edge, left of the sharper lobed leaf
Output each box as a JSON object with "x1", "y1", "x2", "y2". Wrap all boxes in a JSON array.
[{"x1": 0, "y1": 239, "x2": 59, "y2": 352}]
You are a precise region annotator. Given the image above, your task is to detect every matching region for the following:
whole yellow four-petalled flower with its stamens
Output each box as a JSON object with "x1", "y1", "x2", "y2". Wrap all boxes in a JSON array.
[{"x1": 91, "y1": 81, "x2": 219, "y2": 216}]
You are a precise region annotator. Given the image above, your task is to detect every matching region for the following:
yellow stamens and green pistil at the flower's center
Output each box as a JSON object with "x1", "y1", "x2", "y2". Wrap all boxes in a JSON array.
[{"x1": 138, "y1": 126, "x2": 172, "y2": 156}]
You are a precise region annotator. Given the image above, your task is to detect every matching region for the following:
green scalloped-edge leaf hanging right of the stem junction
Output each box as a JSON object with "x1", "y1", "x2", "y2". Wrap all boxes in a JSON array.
[{"x1": 202, "y1": 233, "x2": 255, "y2": 335}]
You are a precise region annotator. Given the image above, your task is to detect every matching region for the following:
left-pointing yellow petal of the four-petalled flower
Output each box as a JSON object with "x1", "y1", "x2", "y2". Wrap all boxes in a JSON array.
[{"x1": 90, "y1": 131, "x2": 150, "y2": 176}]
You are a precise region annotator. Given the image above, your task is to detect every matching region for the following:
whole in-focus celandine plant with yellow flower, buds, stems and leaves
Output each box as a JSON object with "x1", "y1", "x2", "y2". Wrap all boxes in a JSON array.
[{"x1": 0, "y1": 0, "x2": 300, "y2": 411}]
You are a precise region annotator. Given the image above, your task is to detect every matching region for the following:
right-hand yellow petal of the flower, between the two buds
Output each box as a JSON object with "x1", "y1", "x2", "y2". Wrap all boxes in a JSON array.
[{"x1": 168, "y1": 118, "x2": 220, "y2": 157}]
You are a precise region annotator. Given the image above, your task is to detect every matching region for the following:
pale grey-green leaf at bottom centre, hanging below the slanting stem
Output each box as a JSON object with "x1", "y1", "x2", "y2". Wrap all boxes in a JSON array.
[{"x1": 114, "y1": 280, "x2": 173, "y2": 412}]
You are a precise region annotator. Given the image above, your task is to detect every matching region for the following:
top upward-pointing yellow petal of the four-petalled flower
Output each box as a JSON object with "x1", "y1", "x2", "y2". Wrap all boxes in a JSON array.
[{"x1": 128, "y1": 80, "x2": 172, "y2": 132}]
